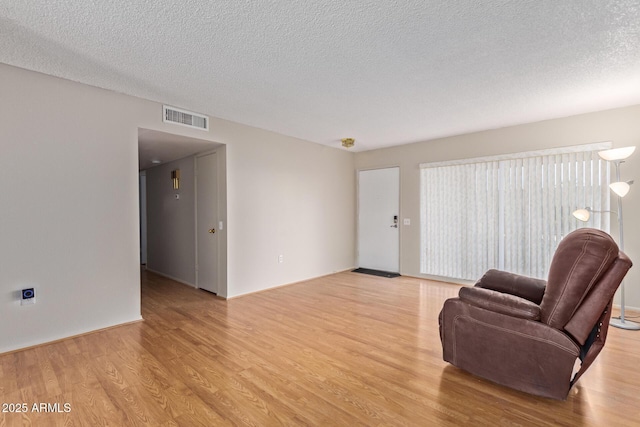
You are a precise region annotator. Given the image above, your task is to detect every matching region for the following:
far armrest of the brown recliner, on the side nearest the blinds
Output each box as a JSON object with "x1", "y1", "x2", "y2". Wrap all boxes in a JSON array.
[{"x1": 475, "y1": 269, "x2": 547, "y2": 304}]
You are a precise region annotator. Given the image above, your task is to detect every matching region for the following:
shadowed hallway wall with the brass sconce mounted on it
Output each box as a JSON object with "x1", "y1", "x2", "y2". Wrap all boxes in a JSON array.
[{"x1": 147, "y1": 156, "x2": 196, "y2": 286}]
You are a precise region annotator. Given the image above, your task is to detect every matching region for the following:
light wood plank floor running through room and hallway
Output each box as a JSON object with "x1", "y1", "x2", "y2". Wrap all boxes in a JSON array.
[{"x1": 0, "y1": 273, "x2": 640, "y2": 426}]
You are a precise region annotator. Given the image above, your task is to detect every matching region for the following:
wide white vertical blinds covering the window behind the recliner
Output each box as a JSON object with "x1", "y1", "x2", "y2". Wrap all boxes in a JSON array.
[{"x1": 420, "y1": 144, "x2": 609, "y2": 280}]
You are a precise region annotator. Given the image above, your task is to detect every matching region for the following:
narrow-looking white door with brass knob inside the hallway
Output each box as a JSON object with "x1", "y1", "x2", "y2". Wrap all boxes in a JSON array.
[{"x1": 196, "y1": 153, "x2": 220, "y2": 294}]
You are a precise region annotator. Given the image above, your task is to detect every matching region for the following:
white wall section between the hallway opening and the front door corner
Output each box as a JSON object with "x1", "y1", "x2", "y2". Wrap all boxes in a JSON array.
[{"x1": 222, "y1": 123, "x2": 356, "y2": 297}]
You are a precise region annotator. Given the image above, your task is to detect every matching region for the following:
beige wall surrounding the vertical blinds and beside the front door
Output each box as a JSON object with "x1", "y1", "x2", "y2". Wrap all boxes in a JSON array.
[{"x1": 356, "y1": 105, "x2": 640, "y2": 308}]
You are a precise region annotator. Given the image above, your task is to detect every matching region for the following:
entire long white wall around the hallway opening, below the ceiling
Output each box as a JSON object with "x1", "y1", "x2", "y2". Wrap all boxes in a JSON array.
[{"x1": 0, "y1": 64, "x2": 355, "y2": 352}]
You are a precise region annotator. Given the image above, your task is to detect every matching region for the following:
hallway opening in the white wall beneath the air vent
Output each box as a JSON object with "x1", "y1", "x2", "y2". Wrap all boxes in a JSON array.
[{"x1": 138, "y1": 129, "x2": 227, "y2": 297}]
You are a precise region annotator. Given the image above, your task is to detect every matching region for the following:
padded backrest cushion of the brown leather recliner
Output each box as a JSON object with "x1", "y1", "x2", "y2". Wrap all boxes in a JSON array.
[{"x1": 540, "y1": 228, "x2": 619, "y2": 329}]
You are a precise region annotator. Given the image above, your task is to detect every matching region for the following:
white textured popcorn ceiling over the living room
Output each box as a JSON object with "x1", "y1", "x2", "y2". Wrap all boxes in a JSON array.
[{"x1": 0, "y1": 0, "x2": 640, "y2": 151}]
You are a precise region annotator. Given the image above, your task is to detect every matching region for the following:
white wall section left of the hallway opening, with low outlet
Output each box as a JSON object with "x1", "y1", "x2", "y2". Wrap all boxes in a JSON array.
[{"x1": 0, "y1": 65, "x2": 140, "y2": 352}]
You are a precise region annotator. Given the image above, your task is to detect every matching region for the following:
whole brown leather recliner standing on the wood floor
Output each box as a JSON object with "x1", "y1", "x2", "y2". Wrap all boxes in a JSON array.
[{"x1": 439, "y1": 228, "x2": 632, "y2": 399}]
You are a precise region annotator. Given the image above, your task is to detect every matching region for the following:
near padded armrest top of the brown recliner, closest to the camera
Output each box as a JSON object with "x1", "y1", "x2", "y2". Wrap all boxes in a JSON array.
[{"x1": 458, "y1": 287, "x2": 540, "y2": 321}]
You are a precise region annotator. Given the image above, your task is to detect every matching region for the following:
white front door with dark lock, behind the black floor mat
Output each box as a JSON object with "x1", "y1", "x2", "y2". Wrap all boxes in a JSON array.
[{"x1": 358, "y1": 168, "x2": 400, "y2": 273}]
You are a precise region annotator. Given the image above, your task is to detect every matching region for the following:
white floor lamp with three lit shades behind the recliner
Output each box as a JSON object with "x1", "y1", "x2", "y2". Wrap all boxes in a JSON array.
[{"x1": 573, "y1": 147, "x2": 640, "y2": 331}]
